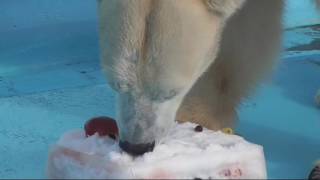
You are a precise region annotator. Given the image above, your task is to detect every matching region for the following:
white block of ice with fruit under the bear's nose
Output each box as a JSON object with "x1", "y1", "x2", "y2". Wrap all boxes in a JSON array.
[{"x1": 47, "y1": 123, "x2": 267, "y2": 179}]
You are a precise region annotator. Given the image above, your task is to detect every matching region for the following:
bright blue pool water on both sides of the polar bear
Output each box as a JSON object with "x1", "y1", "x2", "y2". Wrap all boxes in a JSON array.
[{"x1": 0, "y1": 0, "x2": 320, "y2": 178}]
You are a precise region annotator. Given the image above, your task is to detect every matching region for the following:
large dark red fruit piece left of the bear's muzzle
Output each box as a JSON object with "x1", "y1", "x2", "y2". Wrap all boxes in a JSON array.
[{"x1": 84, "y1": 117, "x2": 119, "y2": 139}]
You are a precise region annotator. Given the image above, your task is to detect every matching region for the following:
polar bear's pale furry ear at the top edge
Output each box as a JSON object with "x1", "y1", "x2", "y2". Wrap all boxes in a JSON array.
[{"x1": 203, "y1": 0, "x2": 246, "y2": 18}]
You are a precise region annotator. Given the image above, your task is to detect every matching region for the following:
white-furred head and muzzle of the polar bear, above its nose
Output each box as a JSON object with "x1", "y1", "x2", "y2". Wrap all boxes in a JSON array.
[{"x1": 100, "y1": 0, "x2": 229, "y2": 143}]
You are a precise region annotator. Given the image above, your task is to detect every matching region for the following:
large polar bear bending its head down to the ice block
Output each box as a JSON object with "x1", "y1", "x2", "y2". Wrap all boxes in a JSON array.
[{"x1": 98, "y1": 0, "x2": 320, "y2": 155}]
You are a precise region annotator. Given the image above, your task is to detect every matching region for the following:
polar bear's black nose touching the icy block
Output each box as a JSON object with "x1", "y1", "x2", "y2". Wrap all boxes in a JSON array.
[{"x1": 119, "y1": 141, "x2": 155, "y2": 156}]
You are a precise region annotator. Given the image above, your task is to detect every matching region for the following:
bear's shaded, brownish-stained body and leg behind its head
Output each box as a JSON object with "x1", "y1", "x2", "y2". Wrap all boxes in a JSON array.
[{"x1": 177, "y1": 0, "x2": 283, "y2": 129}]
